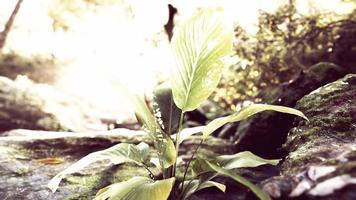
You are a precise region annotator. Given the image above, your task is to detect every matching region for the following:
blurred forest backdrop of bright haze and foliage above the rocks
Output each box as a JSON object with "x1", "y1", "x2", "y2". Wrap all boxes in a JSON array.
[{"x1": 0, "y1": 0, "x2": 356, "y2": 129}]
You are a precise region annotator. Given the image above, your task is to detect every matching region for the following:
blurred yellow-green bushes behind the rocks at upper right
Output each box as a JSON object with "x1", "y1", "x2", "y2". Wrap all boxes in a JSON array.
[{"x1": 212, "y1": 0, "x2": 356, "y2": 110}]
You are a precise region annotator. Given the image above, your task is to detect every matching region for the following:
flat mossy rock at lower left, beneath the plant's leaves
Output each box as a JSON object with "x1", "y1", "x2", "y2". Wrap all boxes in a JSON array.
[{"x1": 0, "y1": 129, "x2": 239, "y2": 200}]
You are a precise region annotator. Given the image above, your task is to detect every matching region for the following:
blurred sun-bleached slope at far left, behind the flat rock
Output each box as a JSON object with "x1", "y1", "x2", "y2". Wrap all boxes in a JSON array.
[{"x1": 0, "y1": 76, "x2": 115, "y2": 132}]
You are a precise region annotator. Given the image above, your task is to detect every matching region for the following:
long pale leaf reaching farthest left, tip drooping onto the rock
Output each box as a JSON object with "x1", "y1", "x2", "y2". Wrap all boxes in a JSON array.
[{"x1": 48, "y1": 143, "x2": 149, "y2": 192}]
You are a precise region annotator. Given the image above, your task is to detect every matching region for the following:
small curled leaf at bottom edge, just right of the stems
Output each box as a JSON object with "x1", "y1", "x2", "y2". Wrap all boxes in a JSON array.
[{"x1": 182, "y1": 179, "x2": 226, "y2": 199}]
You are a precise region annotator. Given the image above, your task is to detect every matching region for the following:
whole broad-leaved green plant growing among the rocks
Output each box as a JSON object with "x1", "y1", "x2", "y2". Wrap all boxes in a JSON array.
[{"x1": 49, "y1": 9, "x2": 306, "y2": 200}]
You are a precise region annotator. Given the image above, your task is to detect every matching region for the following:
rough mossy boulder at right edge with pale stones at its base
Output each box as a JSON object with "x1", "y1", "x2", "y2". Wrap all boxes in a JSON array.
[{"x1": 261, "y1": 75, "x2": 356, "y2": 200}]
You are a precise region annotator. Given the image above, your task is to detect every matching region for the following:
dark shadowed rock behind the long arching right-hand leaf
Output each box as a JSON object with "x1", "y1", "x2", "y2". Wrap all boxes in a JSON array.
[{"x1": 233, "y1": 63, "x2": 345, "y2": 158}]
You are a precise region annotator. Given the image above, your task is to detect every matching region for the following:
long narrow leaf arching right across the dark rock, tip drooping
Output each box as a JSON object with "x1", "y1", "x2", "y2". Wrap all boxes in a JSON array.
[{"x1": 203, "y1": 104, "x2": 308, "y2": 138}]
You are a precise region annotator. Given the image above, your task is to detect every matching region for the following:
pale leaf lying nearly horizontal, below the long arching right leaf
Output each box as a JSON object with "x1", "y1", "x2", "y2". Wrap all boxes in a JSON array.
[{"x1": 215, "y1": 151, "x2": 279, "y2": 169}]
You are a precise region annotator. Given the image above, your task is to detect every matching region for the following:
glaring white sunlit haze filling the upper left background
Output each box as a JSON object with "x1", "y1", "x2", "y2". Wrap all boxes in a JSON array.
[{"x1": 0, "y1": 0, "x2": 351, "y2": 119}]
